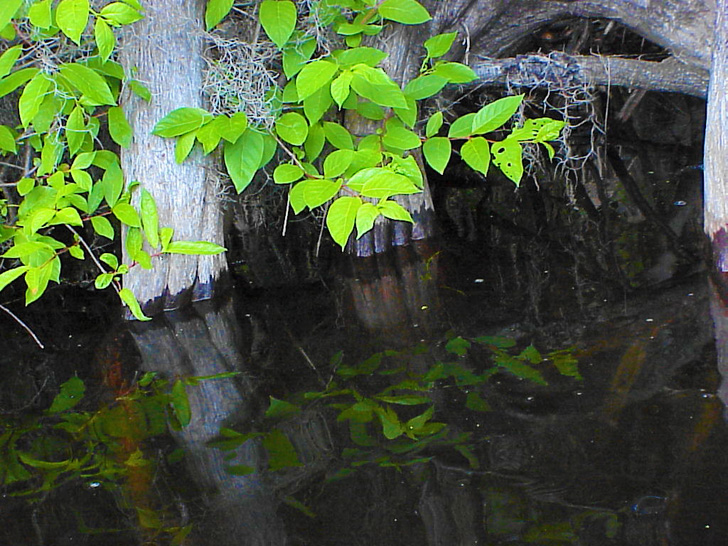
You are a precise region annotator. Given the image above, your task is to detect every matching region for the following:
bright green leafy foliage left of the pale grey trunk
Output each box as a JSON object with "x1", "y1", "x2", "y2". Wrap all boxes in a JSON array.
[{"x1": 0, "y1": 0, "x2": 226, "y2": 320}]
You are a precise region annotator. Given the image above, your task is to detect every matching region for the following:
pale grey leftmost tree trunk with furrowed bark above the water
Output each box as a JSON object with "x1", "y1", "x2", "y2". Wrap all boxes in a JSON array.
[{"x1": 120, "y1": 0, "x2": 226, "y2": 313}]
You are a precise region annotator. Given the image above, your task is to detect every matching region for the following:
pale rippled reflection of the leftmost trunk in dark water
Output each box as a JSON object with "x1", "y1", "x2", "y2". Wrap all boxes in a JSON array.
[{"x1": 128, "y1": 302, "x2": 286, "y2": 546}]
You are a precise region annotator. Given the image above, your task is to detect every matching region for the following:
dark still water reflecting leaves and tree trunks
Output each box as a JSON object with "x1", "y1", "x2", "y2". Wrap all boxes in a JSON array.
[{"x1": 0, "y1": 258, "x2": 728, "y2": 545}]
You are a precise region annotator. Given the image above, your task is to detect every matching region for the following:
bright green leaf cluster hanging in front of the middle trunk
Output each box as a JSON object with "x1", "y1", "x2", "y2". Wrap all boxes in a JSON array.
[{"x1": 154, "y1": 0, "x2": 563, "y2": 253}]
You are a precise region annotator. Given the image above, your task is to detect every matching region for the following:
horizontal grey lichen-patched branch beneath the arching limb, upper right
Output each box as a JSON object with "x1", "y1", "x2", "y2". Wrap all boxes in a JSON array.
[{"x1": 471, "y1": 53, "x2": 708, "y2": 99}]
